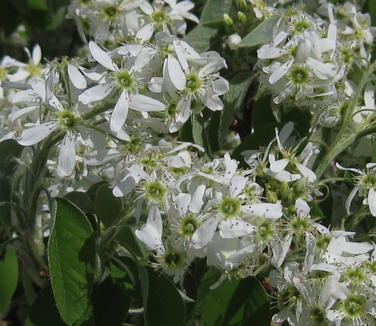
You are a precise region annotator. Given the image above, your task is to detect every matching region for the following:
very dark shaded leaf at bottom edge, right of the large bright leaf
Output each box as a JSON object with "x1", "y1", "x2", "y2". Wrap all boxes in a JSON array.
[{"x1": 93, "y1": 277, "x2": 131, "y2": 326}]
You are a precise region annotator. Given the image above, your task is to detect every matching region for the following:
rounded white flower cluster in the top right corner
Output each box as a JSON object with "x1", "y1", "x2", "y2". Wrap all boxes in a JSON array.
[{"x1": 257, "y1": 1, "x2": 374, "y2": 121}]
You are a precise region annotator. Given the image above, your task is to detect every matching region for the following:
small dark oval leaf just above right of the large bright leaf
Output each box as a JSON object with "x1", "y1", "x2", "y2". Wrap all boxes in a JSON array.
[{"x1": 95, "y1": 185, "x2": 122, "y2": 227}]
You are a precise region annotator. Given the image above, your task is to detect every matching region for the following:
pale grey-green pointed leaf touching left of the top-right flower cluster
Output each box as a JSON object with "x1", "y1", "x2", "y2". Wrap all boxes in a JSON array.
[{"x1": 239, "y1": 16, "x2": 280, "y2": 47}]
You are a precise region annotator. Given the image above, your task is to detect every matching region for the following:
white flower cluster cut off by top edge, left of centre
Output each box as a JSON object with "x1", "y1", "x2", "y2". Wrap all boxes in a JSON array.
[{"x1": 68, "y1": 0, "x2": 199, "y2": 45}]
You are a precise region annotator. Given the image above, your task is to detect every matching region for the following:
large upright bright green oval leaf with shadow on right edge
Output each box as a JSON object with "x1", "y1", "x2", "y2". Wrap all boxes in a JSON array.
[{"x1": 48, "y1": 198, "x2": 95, "y2": 325}]
